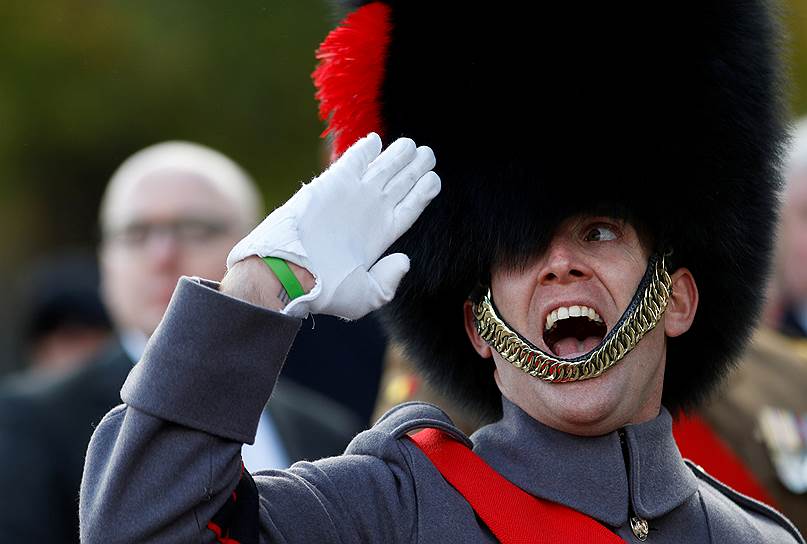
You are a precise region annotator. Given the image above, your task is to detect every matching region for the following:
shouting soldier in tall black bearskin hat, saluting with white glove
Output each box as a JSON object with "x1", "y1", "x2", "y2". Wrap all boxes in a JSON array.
[{"x1": 80, "y1": 1, "x2": 804, "y2": 543}]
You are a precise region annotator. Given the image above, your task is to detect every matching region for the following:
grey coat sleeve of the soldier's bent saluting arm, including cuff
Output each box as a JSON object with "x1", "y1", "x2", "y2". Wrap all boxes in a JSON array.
[{"x1": 79, "y1": 279, "x2": 416, "y2": 543}]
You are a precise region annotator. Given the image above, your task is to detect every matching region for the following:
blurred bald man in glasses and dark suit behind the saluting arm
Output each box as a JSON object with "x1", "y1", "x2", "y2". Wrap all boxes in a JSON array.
[{"x1": 0, "y1": 142, "x2": 359, "y2": 543}]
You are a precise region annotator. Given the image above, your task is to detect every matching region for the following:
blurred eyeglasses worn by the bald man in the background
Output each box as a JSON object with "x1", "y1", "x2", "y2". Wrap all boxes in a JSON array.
[{"x1": 104, "y1": 218, "x2": 232, "y2": 249}]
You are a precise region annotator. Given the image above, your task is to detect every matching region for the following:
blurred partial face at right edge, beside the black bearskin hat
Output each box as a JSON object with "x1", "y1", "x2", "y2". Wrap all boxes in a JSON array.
[{"x1": 779, "y1": 169, "x2": 807, "y2": 304}]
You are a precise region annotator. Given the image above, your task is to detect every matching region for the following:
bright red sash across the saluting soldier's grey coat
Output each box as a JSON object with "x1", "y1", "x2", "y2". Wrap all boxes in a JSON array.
[{"x1": 411, "y1": 429, "x2": 623, "y2": 544}]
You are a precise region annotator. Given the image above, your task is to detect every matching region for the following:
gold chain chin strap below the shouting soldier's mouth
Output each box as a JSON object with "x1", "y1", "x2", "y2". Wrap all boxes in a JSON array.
[{"x1": 473, "y1": 256, "x2": 672, "y2": 382}]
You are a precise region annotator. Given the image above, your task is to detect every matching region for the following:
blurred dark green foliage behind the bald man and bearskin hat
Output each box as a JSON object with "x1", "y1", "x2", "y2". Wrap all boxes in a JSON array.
[{"x1": 0, "y1": 0, "x2": 807, "y2": 371}]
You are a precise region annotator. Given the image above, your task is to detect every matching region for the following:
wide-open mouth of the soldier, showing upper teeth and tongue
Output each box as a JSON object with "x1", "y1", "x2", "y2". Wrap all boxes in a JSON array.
[{"x1": 543, "y1": 305, "x2": 608, "y2": 359}]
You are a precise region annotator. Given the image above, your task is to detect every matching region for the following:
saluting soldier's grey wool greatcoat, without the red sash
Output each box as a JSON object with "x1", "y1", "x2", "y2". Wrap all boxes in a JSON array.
[{"x1": 80, "y1": 279, "x2": 804, "y2": 544}]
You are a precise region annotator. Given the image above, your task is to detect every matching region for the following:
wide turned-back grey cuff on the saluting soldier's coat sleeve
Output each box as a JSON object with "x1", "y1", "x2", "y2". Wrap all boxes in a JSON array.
[{"x1": 121, "y1": 277, "x2": 301, "y2": 444}]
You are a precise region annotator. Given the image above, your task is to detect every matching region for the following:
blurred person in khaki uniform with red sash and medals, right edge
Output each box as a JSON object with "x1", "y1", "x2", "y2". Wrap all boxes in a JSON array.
[{"x1": 681, "y1": 119, "x2": 807, "y2": 533}]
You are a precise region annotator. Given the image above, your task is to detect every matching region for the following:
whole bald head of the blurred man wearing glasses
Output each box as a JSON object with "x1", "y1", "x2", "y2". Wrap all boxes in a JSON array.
[{"x1": 99, "y1": 142, "x2": 263, "y2": 335}]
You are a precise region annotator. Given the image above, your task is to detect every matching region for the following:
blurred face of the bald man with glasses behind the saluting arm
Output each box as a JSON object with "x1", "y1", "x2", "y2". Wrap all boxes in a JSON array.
[{"x1": 101, "y1": 168, "x2": 255, "y2": 336}]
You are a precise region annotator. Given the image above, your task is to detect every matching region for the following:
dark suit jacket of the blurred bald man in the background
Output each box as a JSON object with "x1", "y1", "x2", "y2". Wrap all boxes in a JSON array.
[{"x1": 0, "y1": 334, "x2": 360, "y2": 544}]
